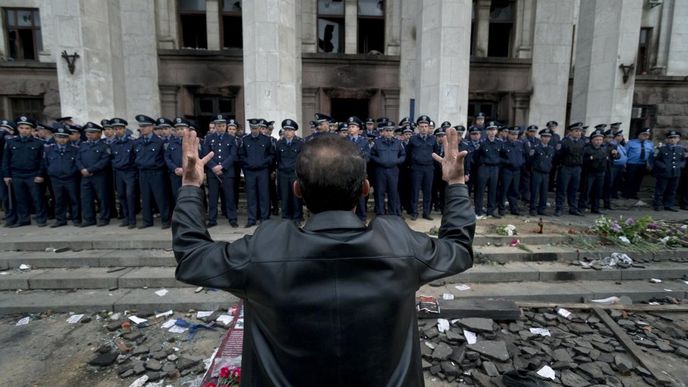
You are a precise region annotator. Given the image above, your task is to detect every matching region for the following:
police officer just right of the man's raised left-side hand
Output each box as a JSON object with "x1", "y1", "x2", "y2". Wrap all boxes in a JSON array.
[{"x1": 201, "y1": 114, "x2": 239, "y2": 228}]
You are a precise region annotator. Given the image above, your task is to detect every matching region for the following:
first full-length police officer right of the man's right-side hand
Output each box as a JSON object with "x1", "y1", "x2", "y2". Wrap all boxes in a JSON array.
[{"x1": 472, "y1": 122, "x2": 503, "y2": 218}]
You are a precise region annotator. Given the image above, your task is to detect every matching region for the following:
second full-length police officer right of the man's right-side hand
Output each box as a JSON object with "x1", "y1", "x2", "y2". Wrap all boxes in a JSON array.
[{"x1": 497, "y1": 126, "x2": 529, "y2": 216}]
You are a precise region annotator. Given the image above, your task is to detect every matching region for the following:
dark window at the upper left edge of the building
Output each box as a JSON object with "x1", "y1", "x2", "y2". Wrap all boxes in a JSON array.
[{"x1": 4, "y1": 8, "x2": 43, "y2": 60}]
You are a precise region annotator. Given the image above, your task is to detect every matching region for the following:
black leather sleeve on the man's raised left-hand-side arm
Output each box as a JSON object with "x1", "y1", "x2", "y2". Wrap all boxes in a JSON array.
[{"x1": 172, "y1": 186, "x2": 251, "y2": 297}]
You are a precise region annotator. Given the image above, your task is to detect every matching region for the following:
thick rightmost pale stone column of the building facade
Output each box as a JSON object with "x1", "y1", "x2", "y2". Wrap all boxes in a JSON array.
[{"x1": 571, "y1": 0, "x2": 643, "y2": 135}]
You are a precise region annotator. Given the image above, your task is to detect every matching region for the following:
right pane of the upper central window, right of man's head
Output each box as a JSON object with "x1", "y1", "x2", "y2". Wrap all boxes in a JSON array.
[{"x1": 358, "y1": 0, "x2": 385, "y2": 54}]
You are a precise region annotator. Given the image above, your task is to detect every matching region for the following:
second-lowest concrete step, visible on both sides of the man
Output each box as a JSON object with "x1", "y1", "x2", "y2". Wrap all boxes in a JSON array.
[{"x1": 0, "y1": 262, "x2": 688, "y2": 290}]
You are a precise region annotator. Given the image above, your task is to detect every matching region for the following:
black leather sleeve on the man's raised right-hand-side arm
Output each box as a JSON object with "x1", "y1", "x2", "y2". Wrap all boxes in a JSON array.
[{"x1": 409, "y1": 184, "x2": 475, "y2": 285}]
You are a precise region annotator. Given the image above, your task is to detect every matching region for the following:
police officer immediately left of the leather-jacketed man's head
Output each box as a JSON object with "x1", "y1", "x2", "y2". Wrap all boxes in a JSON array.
[{"x1": 275, "y1": 118, "x2": 304, "y2": 225}]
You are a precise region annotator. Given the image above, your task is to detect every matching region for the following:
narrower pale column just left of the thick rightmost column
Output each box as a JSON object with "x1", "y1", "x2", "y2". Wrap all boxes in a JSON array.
[{"x1": 527, "y1": 0, "x2": 575, "y2": 134}]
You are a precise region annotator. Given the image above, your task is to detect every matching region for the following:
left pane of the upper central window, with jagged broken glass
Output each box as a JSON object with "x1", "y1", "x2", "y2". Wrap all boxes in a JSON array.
[{"x1": 318, "y1": 0, "x2": 344, "y2": 53}]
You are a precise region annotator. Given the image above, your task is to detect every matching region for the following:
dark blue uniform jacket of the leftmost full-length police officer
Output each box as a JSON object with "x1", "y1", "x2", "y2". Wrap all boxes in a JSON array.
[{"x1": 2, "y1": 136, "x2": 45, "y2": 177}]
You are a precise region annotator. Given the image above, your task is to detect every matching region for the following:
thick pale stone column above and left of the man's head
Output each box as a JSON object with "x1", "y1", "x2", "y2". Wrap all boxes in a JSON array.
[{"x1": 242, "y1": 0, "x2": 303, "y2": 127}]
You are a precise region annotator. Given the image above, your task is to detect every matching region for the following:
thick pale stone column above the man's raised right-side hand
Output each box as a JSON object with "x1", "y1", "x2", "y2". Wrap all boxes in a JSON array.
[{"x1": 416, "y1": 0, "x2": 472, "y2": 125}]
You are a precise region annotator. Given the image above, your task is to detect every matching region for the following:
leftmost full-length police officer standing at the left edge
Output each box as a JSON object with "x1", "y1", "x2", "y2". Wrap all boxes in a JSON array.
[{"x1": 2, "y1": 116, "x2": 47, "y2": 228}]
